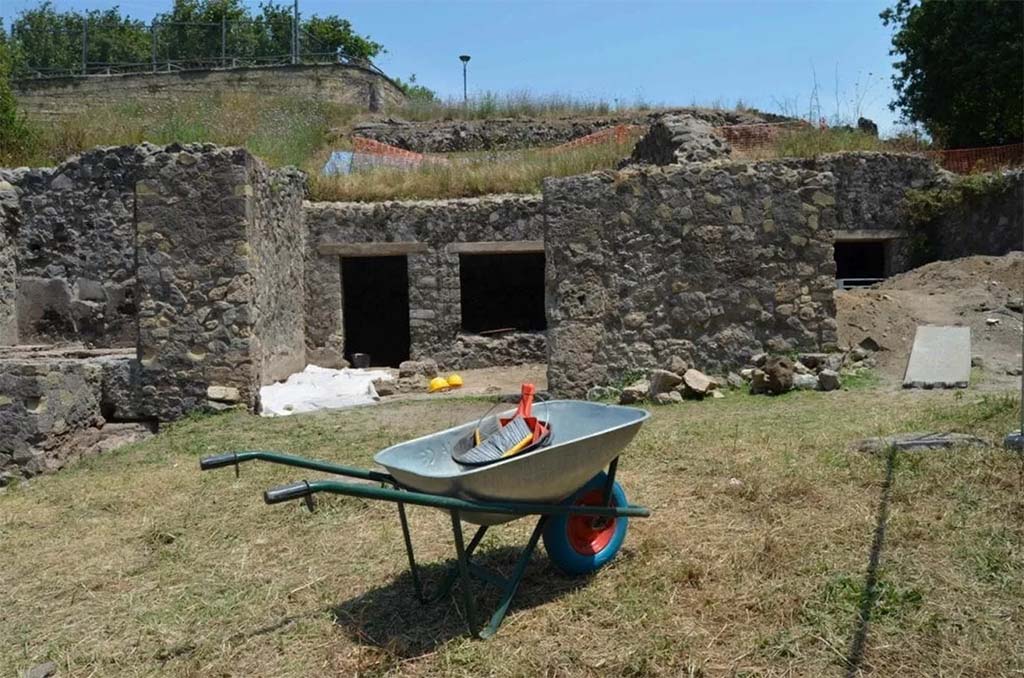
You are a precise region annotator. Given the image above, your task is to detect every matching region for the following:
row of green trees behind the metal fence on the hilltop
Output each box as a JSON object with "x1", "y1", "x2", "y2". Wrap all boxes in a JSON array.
[{"x1": 4, "y1": 0, "x2": 384, "y2": 73}]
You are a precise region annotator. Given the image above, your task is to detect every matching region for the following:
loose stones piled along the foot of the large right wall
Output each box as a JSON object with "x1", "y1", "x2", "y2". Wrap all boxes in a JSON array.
[{"x1": 606, "y1": 346, "x2": 878, "y2": 405}]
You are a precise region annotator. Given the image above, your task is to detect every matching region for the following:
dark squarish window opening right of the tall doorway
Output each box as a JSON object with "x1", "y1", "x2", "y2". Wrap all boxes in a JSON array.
[{"x1": 459, "y1": 252, "x2": 548, "y2": 333}]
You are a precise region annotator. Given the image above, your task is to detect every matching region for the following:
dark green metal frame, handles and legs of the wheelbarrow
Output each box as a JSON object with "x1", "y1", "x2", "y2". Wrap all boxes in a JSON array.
[{"x1": 200, "y1": 450, "x2": 650, "y2": 638}]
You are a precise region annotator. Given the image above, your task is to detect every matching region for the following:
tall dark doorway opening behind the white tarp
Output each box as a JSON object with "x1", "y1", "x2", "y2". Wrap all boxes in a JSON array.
[{"x1": 341, "y1": 256, "x2": 410, "y2": 367}]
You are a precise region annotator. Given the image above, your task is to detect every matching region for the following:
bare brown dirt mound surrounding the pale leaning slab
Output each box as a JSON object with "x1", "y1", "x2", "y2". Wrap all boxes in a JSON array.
[{"x1": 836, "y1": 252, "x2": 1024, "y2": 389}]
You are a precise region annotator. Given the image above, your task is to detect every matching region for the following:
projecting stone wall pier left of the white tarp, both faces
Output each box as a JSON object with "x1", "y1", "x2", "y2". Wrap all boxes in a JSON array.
[{"x1": 135, "y1": 144, "x2": 302, "y2": 420}]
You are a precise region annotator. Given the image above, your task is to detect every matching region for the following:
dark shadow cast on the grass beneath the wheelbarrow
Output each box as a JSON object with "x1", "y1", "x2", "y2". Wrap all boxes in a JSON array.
[{"x1": 332, "y1": 546, "x2": 590, "y2": 659}]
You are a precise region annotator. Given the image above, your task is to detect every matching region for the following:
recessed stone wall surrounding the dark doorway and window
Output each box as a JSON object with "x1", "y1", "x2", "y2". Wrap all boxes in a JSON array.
[{"x1": 306, "y1": 196, "x2": 545, "y2": 369}]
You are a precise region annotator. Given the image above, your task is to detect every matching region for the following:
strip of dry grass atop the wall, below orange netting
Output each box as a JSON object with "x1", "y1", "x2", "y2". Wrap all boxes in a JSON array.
[{"x1": 309, "y1": 140, "x2": 635, "y2": 202}]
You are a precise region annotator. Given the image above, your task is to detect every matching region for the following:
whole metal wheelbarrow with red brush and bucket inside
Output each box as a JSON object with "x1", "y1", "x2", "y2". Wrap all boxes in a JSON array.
[{"x1": 200, "y1": 384, "x2": 650, "y2": 638}]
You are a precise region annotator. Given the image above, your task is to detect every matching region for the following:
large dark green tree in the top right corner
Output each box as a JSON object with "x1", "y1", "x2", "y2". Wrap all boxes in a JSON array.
[{"x1": 881, "y1": 0, "x2": 1024, "y2": 147}]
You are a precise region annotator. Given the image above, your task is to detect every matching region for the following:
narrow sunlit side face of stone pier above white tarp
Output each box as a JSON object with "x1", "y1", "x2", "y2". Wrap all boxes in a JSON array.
[{"x1": 249, "y1": 163, "x2": 306, "y2": 384}]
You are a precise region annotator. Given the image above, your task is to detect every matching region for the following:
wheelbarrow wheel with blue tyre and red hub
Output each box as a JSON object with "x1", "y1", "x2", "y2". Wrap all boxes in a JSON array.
[{"x1": 544, "y1": 471, "x2": 630, "y2": 575}]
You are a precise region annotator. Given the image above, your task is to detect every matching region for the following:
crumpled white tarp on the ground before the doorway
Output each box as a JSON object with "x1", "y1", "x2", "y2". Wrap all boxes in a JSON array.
[{"x1": 259, "y1": 365, "x2": 391, "y2": 417}]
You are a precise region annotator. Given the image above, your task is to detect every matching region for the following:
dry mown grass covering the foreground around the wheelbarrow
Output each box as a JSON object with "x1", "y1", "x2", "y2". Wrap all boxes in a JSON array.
[{"x1": 0, "y1": 389, "x2": 1024, "y2": 677}]
